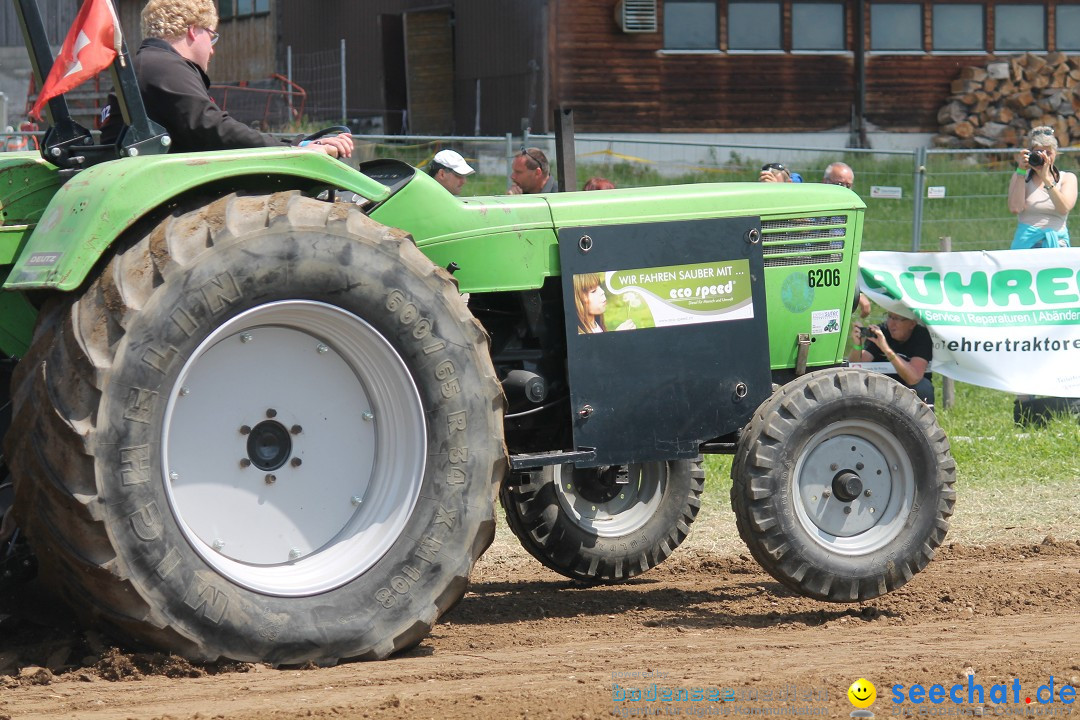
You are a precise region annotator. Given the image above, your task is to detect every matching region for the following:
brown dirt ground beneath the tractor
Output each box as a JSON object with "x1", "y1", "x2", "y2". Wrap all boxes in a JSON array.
[{"x1": 0, "y1": 533, "x2": 1080, "y2": 720}]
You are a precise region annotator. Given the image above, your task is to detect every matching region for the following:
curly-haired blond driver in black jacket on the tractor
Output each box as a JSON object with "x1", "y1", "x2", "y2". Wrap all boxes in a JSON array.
[{"x1": 102, "y1": 0, "x2": 353, "y2": 158}]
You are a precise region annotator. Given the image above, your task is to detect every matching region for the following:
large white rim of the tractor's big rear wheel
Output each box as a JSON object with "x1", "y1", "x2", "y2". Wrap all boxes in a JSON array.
[{"x1": 161, "y1": 300, "x2": 427, "y2": 597}]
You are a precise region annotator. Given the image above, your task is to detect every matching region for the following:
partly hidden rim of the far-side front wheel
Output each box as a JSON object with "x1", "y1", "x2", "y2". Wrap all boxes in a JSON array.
[{"x1": 553, "y1": 463, "x2": 667, "y2": 538}]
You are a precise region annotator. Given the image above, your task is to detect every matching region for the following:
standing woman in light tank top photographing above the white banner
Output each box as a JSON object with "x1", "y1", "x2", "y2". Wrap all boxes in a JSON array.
[{"x1": 1009, "y1": 125, "x2": 1077, "y2": 250}]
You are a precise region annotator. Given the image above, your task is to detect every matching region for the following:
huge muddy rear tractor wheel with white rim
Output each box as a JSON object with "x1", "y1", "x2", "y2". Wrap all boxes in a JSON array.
[{"x1": 6, "y1": 192, "x2": 507, "y2": 665}]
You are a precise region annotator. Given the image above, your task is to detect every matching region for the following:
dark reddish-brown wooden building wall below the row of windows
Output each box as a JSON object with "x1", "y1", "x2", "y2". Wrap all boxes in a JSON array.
[{"x1": 551, "y1": 0, "x2": 1067, "y2": 133}]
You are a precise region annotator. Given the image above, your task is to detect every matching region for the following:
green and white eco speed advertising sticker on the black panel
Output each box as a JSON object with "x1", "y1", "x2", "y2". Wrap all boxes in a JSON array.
[{"x1": 573, "y1": 260, "x2": 754, "y2": 334}]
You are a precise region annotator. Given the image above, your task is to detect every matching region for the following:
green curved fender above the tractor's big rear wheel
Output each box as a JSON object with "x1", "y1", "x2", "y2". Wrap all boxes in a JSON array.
[{"x1": 3, "y1": 147, "x2": 390, "y2": 291}]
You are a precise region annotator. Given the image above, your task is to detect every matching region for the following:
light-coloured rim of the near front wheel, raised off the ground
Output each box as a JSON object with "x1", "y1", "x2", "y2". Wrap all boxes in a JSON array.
[{"x1": 792, "y1": 420, "x2": 915, "y2": 556}]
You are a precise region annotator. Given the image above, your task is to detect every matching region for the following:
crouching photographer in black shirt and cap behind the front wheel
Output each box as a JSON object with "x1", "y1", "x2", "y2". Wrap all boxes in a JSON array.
[{"x1": 848, "y1": 312, "x2": 934, "y2": 407}]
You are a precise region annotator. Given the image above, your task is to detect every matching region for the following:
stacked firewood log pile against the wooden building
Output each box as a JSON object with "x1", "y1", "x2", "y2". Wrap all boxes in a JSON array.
[{"x1": 934, "y1": 53, "x2": 1080, "y2": 148}]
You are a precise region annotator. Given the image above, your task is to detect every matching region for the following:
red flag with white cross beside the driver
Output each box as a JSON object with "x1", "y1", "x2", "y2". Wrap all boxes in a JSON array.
[{"x1": 30, "y1": 0, "x2": 123, "y2": 120}]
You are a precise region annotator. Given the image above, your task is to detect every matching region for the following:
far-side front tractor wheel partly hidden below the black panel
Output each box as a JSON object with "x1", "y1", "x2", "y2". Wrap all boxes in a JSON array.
[{"x1": 501, "y1": 461, "x2": 705, "y2": 584}]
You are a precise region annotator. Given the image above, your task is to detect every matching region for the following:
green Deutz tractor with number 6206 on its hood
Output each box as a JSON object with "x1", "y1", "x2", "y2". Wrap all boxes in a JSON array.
[{"x1": 0, "y1": 0, "x2": 955, "y2": 664}]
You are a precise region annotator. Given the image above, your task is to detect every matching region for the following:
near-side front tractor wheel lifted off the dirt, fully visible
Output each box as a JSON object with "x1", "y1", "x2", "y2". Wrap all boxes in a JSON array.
[{"x1": 731, "y1": 369, "x2": 956, "y2": 602}]
